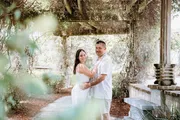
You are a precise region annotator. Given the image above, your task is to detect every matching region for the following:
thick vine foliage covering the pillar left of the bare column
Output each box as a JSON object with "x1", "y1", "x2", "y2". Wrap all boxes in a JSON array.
[{"x1": 129, "y1": 0, "x2": 160, "y2": 82}]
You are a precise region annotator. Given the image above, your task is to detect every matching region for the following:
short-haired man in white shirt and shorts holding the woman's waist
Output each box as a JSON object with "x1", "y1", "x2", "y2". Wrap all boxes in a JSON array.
[{"x1": 83, "y1": 40, "x2": 112, "y2": 120}]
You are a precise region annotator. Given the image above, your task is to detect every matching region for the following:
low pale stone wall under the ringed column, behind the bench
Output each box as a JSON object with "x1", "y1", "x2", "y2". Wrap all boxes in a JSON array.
[{"x1": 129, "y1": 84, "x2": 180, "y2": 111}]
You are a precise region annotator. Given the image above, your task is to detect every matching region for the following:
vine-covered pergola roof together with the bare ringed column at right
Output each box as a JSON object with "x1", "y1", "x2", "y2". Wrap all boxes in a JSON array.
[{"x1": 0, "y1": 0, "x2": 178, "y2": 85}]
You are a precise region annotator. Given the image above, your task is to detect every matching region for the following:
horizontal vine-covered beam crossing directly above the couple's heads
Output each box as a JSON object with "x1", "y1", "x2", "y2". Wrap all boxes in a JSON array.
[{"x1": 54, "y1": 21, "x2": 130, "y2": 36}]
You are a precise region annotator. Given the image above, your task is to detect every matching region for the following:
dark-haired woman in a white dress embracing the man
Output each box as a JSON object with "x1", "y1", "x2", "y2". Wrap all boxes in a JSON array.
[{"x1": 71, "y1": 49, "x2": 96, "y2": 105}]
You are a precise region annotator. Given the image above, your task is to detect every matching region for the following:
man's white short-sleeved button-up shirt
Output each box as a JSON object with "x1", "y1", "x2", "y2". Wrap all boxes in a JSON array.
[{"x1": 91, "y1": 53, "x2": 112, "y2": 99}]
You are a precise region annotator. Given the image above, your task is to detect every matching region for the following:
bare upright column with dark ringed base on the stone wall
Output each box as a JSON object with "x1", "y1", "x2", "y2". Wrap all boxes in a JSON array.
[{"x1": 154, "y1": 0, "x2": 175, "y2": 86}]
